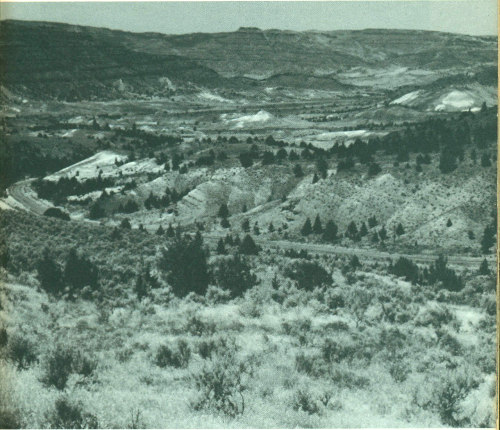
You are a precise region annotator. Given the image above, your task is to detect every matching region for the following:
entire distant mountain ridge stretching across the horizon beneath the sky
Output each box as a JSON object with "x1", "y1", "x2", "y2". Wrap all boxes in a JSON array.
[{"x1": 0, "y1": 20, "x2": 497, "y2": 100}]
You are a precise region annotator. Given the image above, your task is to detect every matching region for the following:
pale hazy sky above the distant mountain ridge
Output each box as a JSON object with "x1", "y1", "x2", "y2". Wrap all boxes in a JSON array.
[{"x1": 0, "y1": 0, "x2": 497, "y2": 35}]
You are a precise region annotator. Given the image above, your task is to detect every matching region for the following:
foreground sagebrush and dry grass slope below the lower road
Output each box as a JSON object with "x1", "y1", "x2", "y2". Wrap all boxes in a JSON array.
[{"x1": 0, "y1": 211, "x2": 496, "y2": 428}]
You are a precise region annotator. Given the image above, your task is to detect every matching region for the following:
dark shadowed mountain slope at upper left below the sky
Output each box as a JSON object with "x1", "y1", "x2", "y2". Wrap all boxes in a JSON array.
[{"x1": 0, "y1": 21, "x2": 222, "y2": 100}]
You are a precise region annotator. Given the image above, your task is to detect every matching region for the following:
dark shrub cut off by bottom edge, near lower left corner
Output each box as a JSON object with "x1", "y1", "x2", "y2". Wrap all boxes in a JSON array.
[{"x1": 48, "y1": 397, "x2": 99, "y2": 429}]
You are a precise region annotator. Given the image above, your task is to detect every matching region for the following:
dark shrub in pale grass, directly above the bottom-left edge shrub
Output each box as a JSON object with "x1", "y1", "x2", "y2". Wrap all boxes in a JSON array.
[{"x1": 41, "y1": 346, "x2": 97, "y2": 390}]
